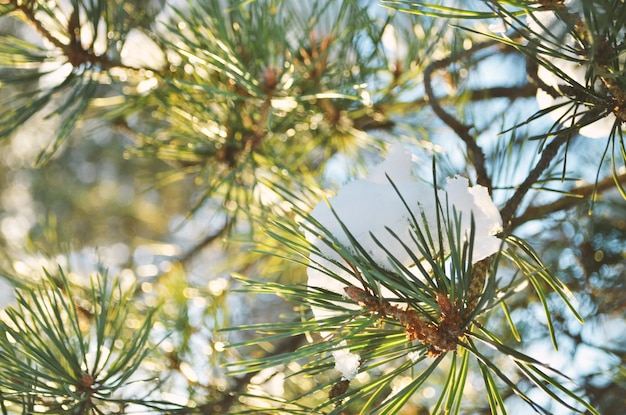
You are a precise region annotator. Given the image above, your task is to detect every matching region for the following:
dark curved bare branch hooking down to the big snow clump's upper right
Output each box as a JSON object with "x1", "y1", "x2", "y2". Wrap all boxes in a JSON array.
[{"x1": 424, "y1": 41, "x2": 497, "y2": 193}]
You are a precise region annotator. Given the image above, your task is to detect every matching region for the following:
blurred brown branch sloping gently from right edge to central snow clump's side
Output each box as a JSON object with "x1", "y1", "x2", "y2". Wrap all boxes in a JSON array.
[{"x1": 511, "y1": 173, "x2": 626, "y2": 228}]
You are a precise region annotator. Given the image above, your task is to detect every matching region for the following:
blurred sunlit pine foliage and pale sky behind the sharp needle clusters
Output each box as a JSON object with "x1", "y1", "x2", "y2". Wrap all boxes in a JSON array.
[{"x1": 0, "y1": 0, "x2": 626, "y2": 415}]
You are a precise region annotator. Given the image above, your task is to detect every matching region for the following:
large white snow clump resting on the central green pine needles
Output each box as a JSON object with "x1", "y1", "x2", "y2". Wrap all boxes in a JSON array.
[{"x1": 305, "y1": 145, "x2": 502, "y2": 320}]
